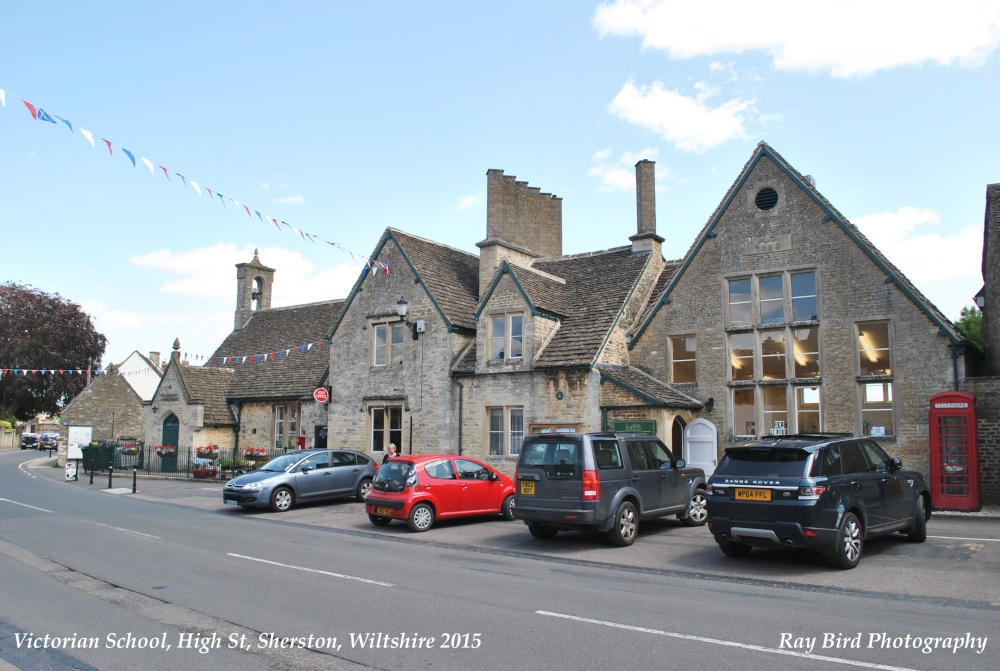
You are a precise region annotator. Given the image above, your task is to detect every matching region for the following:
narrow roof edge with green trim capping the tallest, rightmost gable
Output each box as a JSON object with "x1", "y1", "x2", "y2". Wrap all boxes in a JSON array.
[{"x1": 633, "y1": 142, "x2": 965, "y2": 346}]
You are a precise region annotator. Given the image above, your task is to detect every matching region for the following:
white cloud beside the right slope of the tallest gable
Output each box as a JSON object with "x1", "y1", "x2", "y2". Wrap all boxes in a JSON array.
[{"x1": 852, "y1": 207, "x2": 983, "y2": 284}]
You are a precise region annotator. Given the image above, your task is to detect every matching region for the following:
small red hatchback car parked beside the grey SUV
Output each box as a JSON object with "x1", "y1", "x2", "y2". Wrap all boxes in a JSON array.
[{"x1": 365, "y1": 454, "x2": 514, "y2": 531}]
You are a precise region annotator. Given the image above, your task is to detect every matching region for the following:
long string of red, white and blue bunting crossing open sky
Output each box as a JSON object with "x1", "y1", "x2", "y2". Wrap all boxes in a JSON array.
[{"x1": 0, "y1": 89, "x2": 389, "y2": 275}]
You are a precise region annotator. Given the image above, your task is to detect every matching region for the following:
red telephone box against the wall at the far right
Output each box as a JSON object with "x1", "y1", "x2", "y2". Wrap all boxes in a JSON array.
[{"x1": 928, "y1": 391, "x2": 980, "y2": 510}]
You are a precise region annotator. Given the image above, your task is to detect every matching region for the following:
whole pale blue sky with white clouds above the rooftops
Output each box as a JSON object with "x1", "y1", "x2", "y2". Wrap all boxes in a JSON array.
[{"x1": 0, "y1": 0, "x2": 1000, "y2": 363}]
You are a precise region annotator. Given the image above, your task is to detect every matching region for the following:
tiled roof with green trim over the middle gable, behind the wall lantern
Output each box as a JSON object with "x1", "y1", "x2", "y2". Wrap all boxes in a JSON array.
[{"x1": 326, "y1": 228, "x2": 479, "y2": 339}]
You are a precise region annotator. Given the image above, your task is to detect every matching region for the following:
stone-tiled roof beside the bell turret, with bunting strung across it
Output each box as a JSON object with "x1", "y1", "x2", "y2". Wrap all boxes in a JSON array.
[{"x1": 205, "y1": 300, "x2": 344, "y2": 400}]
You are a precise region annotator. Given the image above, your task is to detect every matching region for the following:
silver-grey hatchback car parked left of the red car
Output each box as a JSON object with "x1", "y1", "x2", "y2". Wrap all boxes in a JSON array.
[{"x1": 222, "y1": 450, "x2": 378, "y2": 512}]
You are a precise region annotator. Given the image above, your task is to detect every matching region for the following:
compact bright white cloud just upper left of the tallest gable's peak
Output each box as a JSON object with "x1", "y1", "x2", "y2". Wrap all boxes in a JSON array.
[{"x1": 610, "y1": 81, "x2": 754, "y2": 152}]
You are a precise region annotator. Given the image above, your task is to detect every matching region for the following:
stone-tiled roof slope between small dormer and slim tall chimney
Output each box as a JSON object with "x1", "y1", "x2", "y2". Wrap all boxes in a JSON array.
[{"x1": 532, "y1": 247, "x2": 651, "y2": 369}]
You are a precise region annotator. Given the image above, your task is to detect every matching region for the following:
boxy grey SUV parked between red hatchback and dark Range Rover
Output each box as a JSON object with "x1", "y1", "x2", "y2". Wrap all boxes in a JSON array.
[{"x1": 514, "y1": 433, "x2": 707, "y2": 546}]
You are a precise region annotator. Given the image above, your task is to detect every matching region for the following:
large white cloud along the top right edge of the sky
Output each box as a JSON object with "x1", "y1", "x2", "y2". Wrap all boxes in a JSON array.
[{"x1": 593, "y1": 0, "x2": 1000, "y2": 77}]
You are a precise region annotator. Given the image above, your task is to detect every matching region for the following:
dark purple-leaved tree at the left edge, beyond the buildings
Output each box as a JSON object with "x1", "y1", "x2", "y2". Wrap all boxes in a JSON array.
[{"x1": 0, "y1": 282, "x2": 107, "y2": 420}]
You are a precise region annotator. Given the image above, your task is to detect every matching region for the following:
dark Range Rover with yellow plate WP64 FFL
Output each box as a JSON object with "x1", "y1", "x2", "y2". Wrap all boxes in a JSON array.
[{"x1": 708, "y1": 434, "x2": 931, "y2": 568}]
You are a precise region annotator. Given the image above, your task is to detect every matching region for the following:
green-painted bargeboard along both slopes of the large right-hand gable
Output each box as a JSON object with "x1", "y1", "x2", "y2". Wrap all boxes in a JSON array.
[{"x1": 628, "y1": 146, "x2": 961, "y2": 349}]
